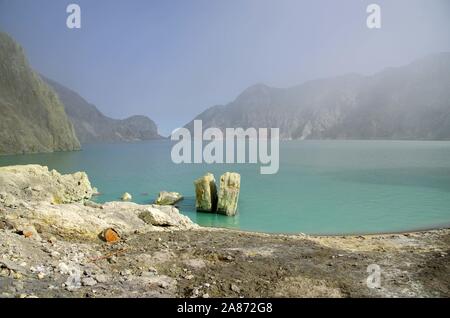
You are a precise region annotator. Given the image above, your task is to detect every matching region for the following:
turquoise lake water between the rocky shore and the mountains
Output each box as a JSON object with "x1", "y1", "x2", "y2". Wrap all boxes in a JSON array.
[{"x1": 0, "y1": 140, "x2": 450, "y2": 234}]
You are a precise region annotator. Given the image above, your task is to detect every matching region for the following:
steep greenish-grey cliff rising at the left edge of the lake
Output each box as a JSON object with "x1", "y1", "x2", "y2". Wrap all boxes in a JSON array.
[{"x1": 0, "y1": 32, "x2": 80, "y2": 154}]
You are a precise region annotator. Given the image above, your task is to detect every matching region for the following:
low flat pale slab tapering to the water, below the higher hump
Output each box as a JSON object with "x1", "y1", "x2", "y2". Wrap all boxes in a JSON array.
[{"x1": 2, "y1": 202, "x2": 197, "y2": 240}]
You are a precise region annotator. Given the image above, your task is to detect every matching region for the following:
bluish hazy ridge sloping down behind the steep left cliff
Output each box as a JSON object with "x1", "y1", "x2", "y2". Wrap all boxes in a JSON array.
[{"x1": 44, "y1": 77, "x2": 162, "y2": 144}]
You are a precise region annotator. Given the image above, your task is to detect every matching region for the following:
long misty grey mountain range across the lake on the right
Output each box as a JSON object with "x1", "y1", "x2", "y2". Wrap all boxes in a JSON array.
[{"x1": 186, "y1": 53, "x2": 450, "y2": 140}]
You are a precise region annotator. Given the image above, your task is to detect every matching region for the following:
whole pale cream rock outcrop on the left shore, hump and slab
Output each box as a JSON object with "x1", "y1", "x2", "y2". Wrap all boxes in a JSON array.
[{"x1": 0, "y1": 166, "x2": 197, "y2": 240}]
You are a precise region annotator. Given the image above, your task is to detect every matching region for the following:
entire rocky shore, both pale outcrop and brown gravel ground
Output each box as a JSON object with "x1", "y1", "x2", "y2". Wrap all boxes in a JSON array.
[{"x1": 0, "y1": 165, "x2": 450, "y2": 298}]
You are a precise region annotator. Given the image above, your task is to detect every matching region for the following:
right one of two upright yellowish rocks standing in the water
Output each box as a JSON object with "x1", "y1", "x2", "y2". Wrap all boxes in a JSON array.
[{"x1": 217, "y1": 172, "x2": 241, "y2": 216}]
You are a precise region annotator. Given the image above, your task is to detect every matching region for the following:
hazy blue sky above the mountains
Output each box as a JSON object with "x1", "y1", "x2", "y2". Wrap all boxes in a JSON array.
[{"x1": 0, "y1": 0, "x2": 450, "y2": 134}]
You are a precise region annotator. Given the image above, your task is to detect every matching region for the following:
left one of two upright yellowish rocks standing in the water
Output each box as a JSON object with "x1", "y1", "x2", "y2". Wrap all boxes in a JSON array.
[{"x1": 194, "y1": 173, "x2": 217, "y2": 212}]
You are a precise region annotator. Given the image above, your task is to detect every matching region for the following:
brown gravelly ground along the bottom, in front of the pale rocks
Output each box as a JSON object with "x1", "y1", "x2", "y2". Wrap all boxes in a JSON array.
[{"x1": 0, "y1": 223, "x2": 450, "y2": 298}]
